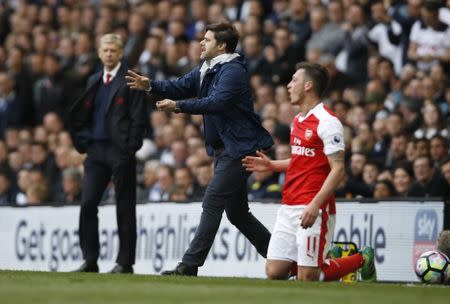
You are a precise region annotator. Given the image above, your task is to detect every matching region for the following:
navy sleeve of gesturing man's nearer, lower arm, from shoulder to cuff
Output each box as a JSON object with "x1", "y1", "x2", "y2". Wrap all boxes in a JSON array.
[{"x1": 177, "y1": 64, "x2": 248, "y2": 114}]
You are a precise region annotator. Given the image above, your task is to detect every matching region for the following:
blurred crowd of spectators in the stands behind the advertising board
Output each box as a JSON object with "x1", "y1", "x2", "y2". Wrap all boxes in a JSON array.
[{"x1": 0, "y1": 0, "x2": 450, "y2": 205}]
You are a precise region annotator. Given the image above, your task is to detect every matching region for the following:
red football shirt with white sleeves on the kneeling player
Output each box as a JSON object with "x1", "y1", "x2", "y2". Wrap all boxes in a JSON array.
[{"x1": 283, "y1": 103, "x2": 345, "y2": 214}]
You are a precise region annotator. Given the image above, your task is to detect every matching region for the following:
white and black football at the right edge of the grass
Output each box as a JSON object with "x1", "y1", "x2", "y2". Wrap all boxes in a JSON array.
[{"x1": 416, "y1": 251, "x2": 450, "y2": 284}]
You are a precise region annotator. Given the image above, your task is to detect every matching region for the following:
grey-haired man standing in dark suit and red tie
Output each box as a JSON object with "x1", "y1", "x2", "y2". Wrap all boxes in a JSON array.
[{"x1": 70, "y1": 34, "x2": 146, "y2": 273}]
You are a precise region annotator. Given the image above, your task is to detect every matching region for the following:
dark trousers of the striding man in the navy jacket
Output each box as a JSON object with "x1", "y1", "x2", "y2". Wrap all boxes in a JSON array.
[{"x1": 182, "y1": 149, "x2": 270, "y2": 266}]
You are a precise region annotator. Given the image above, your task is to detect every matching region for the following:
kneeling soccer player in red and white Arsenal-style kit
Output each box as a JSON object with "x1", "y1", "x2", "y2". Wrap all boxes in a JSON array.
[{"x1": 243, "y1": 63, "x2": 376, "y2": 281}]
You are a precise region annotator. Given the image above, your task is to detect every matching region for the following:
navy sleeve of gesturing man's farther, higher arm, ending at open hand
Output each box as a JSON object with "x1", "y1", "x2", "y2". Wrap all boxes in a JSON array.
[{"x1": 150, "y1": 67, "x2": 200, "y2": 100}]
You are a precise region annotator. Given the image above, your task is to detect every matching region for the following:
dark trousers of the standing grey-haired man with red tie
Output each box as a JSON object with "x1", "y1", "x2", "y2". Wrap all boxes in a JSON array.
[{"x1": 79, "y1": 142, "x2": 137, "y2": 266}]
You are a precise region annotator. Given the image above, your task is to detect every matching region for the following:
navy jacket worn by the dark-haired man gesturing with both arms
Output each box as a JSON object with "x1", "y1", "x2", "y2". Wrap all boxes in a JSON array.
[{"x1": 152, "y1": 57, "x2": 273, "y2": 159}]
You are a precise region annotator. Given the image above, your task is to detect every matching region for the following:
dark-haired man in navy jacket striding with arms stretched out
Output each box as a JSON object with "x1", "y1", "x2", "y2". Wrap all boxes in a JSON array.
[{"x1": 126, "y1": 23, "x2": 273, "y2": 276}]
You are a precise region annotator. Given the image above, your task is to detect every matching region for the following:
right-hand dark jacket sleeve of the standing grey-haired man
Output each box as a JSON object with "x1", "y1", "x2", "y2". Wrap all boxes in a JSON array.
[{"x1": 128, "y1": 90, "x2": 147, "y2": 153}]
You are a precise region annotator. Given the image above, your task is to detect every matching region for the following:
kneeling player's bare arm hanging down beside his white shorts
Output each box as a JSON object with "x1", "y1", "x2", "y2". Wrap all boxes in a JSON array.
[{"x1": 300, "y1": 150, "x2": 345, "y2": 229}]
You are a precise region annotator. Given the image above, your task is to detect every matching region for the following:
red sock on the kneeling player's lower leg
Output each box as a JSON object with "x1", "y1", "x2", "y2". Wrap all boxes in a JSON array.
[{"x1": 320, "y1": 253, "x2": 364, "y2": 281}]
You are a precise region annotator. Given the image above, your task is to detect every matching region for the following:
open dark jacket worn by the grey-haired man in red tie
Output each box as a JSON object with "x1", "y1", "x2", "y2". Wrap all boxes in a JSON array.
[{"x1": 69, "y1": 63, "x2": 147, "y2": 154}]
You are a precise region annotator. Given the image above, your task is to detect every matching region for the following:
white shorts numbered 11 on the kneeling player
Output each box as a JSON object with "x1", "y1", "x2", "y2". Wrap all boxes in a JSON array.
[{"x1": 267, "y1": 205, "x2": 336, "y2": 267}]
